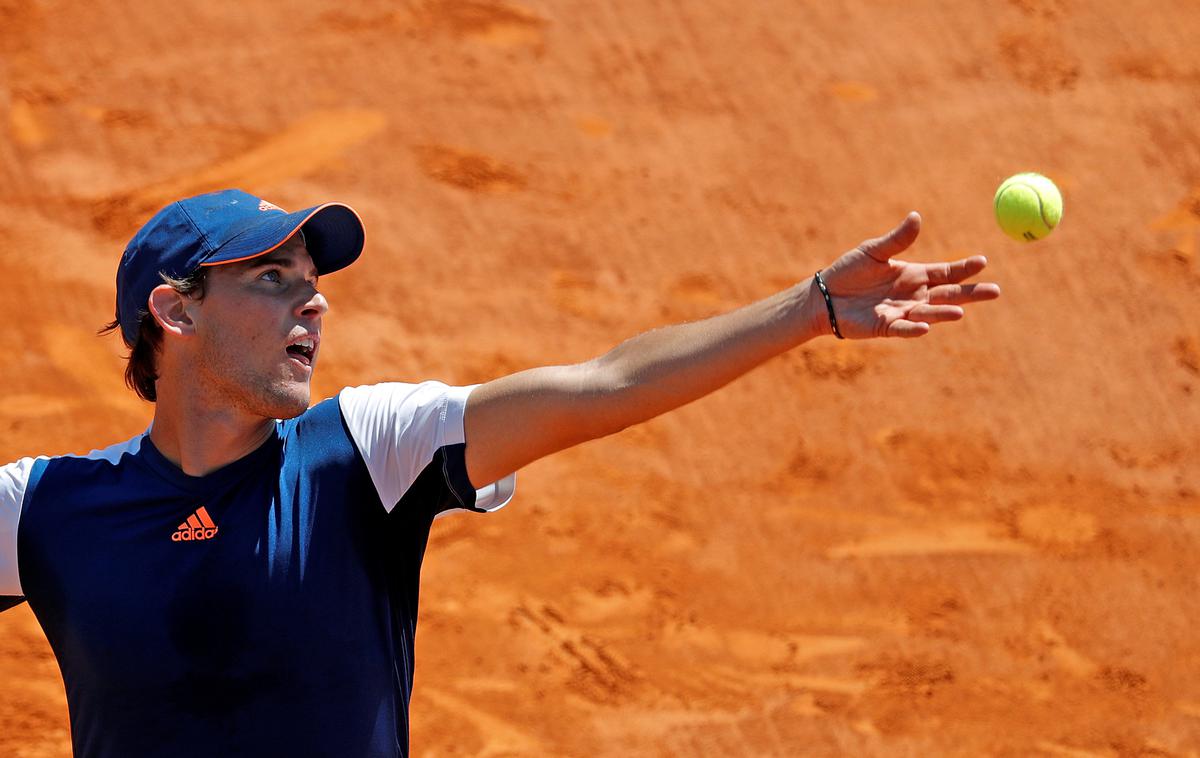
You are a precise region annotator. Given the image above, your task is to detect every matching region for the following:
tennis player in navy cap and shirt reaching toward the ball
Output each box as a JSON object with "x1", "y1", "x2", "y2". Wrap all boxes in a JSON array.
[{"x1": 0, "y1": 190, "x2": 1000, "y2": 758}]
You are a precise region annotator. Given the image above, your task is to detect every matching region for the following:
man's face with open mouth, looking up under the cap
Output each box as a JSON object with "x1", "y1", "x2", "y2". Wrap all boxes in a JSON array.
[{"x1": 193, "y1": 234, "x2": 329, "y2": 419}]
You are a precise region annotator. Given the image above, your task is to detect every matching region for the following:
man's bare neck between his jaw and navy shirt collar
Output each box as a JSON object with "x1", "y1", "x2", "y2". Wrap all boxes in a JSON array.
[{"x1": 150, "y1": 381, "x2": 275, "y2": 476}]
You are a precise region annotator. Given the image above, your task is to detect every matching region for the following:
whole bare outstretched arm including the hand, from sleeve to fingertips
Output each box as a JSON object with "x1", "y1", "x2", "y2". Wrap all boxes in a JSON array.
[{"x1": 466, "y1": 213, "x2": 1000, "y2": 485}]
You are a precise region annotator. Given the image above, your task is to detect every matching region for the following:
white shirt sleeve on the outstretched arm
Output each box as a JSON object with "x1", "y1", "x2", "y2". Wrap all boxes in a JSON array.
[{"x1": 337, "y1": 381, "x2": 516, "y2": 512}]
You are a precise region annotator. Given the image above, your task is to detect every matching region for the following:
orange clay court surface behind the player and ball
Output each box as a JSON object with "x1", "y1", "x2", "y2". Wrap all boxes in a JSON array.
[{"x1": 0, "y1": 0, "x2": 1200, "y2": 758}]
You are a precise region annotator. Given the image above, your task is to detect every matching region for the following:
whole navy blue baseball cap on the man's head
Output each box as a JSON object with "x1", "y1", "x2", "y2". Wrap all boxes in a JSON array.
[{"x1": 116, "y1": 190, "x2": 364, "y2": 347}]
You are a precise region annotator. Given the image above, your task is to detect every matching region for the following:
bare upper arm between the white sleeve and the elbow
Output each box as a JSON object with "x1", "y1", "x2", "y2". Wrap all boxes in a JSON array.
[{"x1": 464, "y1": 361, "x2": 609, "y2": 491}]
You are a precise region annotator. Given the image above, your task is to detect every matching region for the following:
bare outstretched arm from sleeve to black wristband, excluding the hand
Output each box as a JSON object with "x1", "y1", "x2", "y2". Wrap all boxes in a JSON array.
[{"x1": 466, "y1": 275, "x2": 829, "y2": 483}]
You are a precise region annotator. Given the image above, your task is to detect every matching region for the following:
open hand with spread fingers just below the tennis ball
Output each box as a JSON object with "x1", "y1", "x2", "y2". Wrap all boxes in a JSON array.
[{"x1": 812, "y1": 212, "x2": 1000, "y2": 339}]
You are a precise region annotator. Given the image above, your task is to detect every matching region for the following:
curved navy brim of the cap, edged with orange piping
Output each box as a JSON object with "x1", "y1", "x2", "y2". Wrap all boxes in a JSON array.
[{"x1": 200, "y1": 203, "x2": 366, "y2": 275}]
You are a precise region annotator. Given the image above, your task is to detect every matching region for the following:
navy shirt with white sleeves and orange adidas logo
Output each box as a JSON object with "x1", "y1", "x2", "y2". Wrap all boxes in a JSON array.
[{"x1": 0, "y1": 383, "x2": 515, "y2": 758}]
